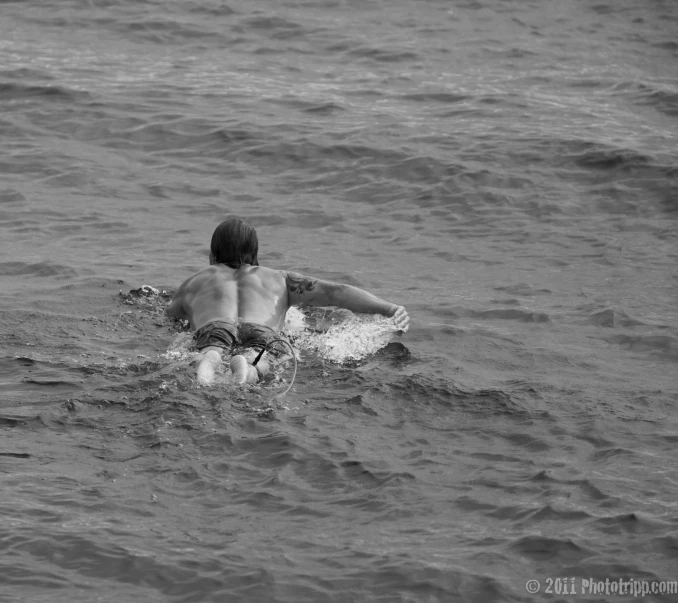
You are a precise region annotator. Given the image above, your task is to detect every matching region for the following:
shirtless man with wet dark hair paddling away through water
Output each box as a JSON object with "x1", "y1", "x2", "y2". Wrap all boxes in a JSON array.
[{"x1": 165, "y1": 218, "x2": 410, "y2": 385}]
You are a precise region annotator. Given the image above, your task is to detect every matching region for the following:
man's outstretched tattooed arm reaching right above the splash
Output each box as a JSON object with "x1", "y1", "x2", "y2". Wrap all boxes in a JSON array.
[{"x1": 285, "y1": 272, "x2": 410, "y2": 331}]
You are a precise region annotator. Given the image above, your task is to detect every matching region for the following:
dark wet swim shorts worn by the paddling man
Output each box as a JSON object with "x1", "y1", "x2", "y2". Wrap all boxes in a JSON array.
[{"x1": 195, "y1": 320, "x2": 289, "y2": 356}]
